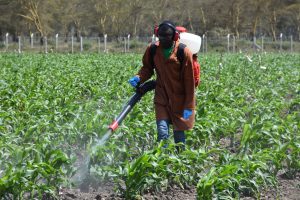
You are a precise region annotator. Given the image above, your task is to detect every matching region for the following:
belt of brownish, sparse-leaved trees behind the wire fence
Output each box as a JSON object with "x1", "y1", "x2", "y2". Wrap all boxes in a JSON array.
[{"x1": 0, "y1": 0, "x2": 300, "y2": 40}]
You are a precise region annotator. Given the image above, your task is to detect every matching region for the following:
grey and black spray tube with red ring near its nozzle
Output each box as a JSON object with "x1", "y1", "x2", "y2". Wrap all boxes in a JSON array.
[{"x1": 108, "y1": 80, "x2": 156, "y2": 131}]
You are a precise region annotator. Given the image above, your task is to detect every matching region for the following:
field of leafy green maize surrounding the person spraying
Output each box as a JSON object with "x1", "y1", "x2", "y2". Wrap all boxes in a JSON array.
[{"x1": 0, "y1": 54, "x2": 300, "y2": 199}]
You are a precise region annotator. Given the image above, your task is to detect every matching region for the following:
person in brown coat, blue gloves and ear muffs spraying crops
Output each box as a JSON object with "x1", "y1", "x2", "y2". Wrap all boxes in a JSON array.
[{"x1": 129, "y1": 21, "x2": 195, "y2": 150}]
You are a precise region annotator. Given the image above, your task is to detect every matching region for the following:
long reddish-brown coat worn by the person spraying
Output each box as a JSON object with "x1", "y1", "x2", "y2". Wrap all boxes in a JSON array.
[{"x1": 137, "y1": 42, "x2": 195, "y2": 130}]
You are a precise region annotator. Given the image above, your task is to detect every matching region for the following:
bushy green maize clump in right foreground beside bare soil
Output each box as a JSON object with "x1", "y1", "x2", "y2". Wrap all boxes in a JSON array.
[{"x1": 197, "y1": 152, "x2": 275, "y2": 199}]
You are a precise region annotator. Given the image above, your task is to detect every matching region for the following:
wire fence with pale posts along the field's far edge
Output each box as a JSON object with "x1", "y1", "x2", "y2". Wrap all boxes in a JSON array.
[{"x1": 0, "y1": 34, "x2": 300, "y2": 53}]
